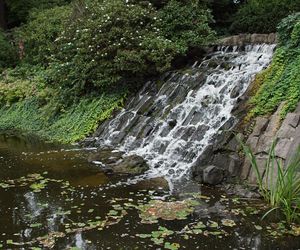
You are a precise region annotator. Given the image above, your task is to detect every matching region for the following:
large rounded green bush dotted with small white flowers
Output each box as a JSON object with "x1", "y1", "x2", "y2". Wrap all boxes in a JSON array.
[{"x1": 51, "y1": 0, "x2": 180, "y2": 95}]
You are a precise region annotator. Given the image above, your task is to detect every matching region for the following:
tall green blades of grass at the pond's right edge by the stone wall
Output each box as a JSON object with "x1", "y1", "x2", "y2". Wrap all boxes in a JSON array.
[{"x1": 238, "y1": 139, "x2": 300, "y2": 223}]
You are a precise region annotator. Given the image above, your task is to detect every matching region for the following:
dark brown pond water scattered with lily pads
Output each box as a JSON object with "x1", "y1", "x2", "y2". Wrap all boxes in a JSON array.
[{"x1": 0, "y1": 135, "x2": 300, "y2": 249}]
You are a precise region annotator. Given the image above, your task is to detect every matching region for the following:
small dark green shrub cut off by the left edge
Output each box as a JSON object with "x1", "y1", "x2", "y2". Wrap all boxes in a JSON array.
[{"x1": 0, "y1": 29, "x2": 17, "y2": 72}]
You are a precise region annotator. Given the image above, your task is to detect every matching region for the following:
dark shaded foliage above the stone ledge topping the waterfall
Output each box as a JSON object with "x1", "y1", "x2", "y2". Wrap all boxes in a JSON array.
[{"x1": 231, "y1": 0, "x2": 300, "y2": 33}]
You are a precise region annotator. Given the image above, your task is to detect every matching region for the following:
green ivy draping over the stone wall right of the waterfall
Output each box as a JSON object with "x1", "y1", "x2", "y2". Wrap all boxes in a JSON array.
[{"x1": 251, "y1": 13, "x2": 300, "y2": 117}]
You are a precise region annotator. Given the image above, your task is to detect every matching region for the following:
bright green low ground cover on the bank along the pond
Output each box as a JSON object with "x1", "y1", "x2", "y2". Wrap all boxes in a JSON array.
[{"x1": 0, "y1": 94, "x2": 124, "y2": 143}]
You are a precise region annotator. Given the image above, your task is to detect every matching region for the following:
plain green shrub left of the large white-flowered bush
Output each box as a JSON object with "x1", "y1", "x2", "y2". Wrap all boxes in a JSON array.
[{"x1": 16, "y1": 6, "x2": 71, "y2": 65}]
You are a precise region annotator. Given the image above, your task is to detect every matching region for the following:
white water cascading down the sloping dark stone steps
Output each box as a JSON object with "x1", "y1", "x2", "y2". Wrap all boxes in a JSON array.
[{"x1": 92, "y1": 44, "x2": 275, "y2": 182}]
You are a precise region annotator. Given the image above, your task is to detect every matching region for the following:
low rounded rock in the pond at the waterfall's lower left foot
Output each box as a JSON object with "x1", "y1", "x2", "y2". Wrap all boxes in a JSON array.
[{"x1": 111, "y1": 155, "x2": 149, "y2": 175}]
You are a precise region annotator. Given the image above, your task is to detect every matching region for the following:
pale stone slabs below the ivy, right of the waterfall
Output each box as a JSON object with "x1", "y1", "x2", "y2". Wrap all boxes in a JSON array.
[{"x1": 241, "y1": 103, "x2": 300, "y2": 184}]
